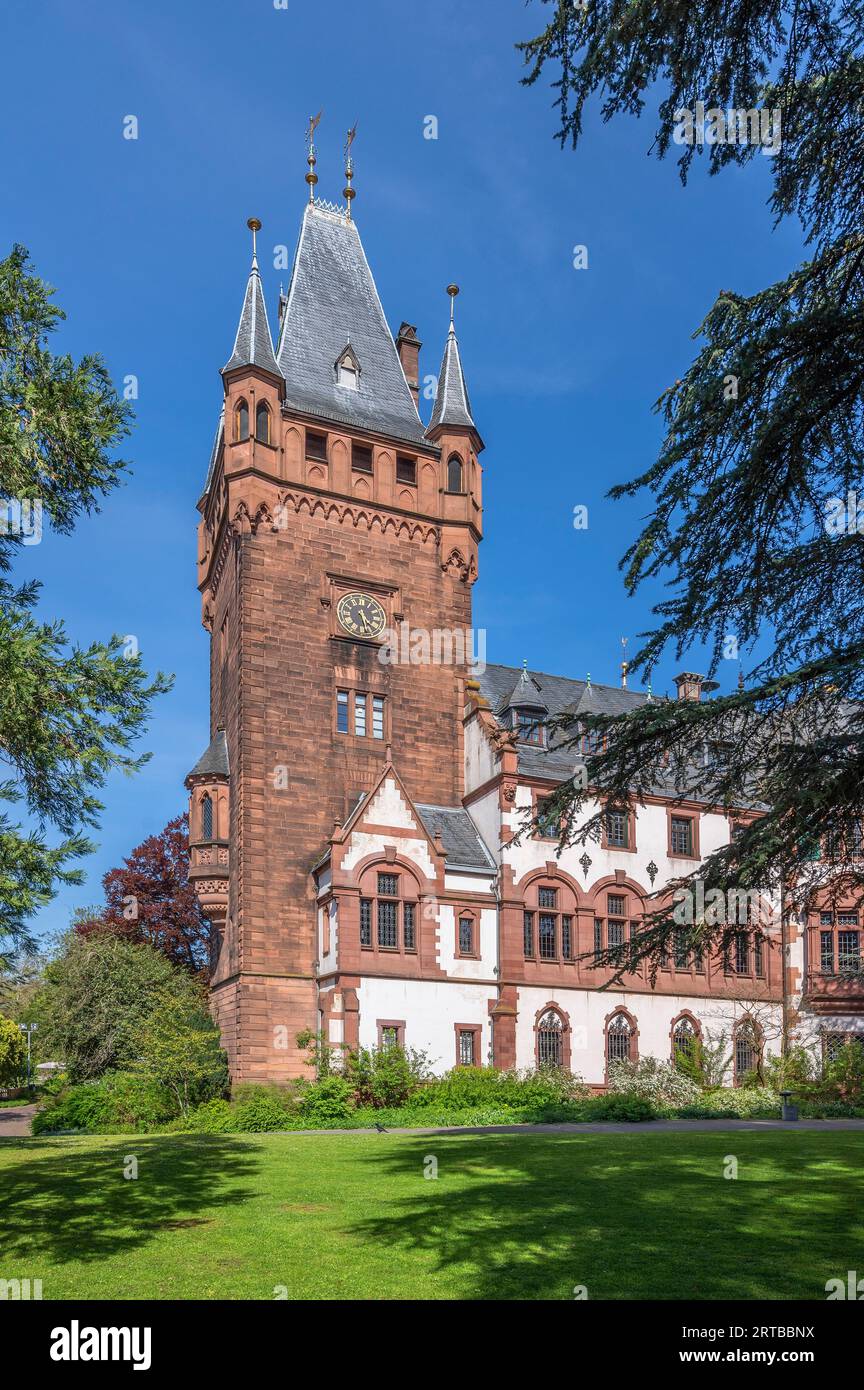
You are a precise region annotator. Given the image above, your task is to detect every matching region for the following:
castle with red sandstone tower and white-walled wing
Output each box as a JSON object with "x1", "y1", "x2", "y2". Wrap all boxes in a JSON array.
[{"x1": 186, "y1": 179, "x2": 864, "y2": 1087}]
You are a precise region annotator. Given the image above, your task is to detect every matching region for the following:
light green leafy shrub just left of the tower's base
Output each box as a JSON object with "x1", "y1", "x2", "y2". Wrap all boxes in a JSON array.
[{"x1": 139, "y1": 977, "x2": 228, "y2": 1115}]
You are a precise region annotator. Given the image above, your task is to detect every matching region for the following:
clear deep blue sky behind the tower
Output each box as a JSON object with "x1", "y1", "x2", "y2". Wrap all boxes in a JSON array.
[{"x1": 0, "y1": 0, "x2": 801, "y2": 931}]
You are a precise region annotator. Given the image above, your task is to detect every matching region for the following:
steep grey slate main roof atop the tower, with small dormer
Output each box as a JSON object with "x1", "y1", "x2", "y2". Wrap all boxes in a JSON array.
[{"x1": 276, "y1": 203, "x2": 424, "y2": 443}]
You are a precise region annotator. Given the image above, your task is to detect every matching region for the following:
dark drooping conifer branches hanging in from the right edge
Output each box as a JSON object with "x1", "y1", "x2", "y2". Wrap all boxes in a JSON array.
[{"x1": 521, "y1": 0, "x2": 864, "y2": 980}]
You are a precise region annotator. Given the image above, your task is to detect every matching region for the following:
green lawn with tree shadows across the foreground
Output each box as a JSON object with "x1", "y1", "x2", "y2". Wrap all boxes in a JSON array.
[{"x1": 0, "y1": 1130, "x2": 864, "y2": 1300}]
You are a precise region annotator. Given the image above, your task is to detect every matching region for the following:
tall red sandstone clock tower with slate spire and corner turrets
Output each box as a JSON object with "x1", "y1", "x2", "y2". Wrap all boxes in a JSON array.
[{"x1": 188, "y1": 190, "x2": 483, "y2": 1080}]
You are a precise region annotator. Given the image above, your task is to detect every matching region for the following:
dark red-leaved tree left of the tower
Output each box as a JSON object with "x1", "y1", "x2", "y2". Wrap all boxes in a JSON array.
[{"x1": 75, "y1": 816, "x2": 210, "y2": 973}]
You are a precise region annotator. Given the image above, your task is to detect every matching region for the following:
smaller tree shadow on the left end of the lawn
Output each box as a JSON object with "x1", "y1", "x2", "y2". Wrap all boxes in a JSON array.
[{"x1": 0, "y1": 1134, "x2": 261, "y2": 1264}]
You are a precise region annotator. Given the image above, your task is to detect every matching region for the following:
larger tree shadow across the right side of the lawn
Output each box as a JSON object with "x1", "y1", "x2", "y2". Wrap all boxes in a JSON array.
[{"x1": 351, "y1": 1131, "x2": 864, "y2": 1300}]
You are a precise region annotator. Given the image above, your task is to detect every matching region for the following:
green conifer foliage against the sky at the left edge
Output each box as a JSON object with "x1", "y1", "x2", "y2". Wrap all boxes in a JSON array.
[{"x1": 0, "y1": 246, "x2": 171, "y2": 947}]
